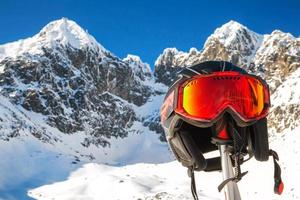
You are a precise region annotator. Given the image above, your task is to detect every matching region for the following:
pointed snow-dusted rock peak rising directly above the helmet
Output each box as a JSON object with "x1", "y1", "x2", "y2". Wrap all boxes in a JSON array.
[{"x1": 201, "y1": 21, "x2": 263, "y2": 69}]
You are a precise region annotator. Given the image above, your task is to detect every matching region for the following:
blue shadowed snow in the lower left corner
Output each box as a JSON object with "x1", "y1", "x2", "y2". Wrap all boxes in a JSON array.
[{"x1": 0, "y1": 136, "x2": 81, "y2": 200}]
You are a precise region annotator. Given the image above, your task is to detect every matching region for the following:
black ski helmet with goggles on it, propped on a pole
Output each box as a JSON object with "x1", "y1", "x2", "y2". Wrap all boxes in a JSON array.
[{"x1": 160, "y1": 61, "x2": 270, "y2": 171}]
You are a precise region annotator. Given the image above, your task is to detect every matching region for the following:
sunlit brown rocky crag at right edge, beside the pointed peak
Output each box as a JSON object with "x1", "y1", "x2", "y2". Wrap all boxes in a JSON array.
[{"x1": 253, "y1": 31, "x2": 300, "y2": 91}]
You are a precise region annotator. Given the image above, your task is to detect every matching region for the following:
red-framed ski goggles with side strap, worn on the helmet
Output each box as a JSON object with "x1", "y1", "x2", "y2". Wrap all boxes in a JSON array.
[{"x1": 161, "y1": 71, "x2": 270, "y2": 124}]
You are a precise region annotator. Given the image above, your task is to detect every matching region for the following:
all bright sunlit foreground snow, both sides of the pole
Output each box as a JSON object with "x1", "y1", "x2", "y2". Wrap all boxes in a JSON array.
[{"x1": 28, "y1": 128, "x2": 300, "y2": 200}]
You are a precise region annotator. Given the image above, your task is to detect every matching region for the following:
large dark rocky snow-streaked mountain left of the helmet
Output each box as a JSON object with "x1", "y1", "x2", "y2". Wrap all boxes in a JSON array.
[{"x1": 0, "y1": 18, "x2": 166, "y2": 157}]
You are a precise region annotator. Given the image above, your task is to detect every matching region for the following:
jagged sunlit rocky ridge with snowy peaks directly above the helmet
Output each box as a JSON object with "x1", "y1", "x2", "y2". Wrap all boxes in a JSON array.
[{"x1": 154, "y1": 21, "x2": 300, "y2": 92}]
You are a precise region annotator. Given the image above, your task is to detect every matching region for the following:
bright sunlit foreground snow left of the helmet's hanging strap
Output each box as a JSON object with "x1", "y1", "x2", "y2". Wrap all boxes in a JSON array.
[{"x1": 29, "y1": 162, "x2": 218, "y2": 199}]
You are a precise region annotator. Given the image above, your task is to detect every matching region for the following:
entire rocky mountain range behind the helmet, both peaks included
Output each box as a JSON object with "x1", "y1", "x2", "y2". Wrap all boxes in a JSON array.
[{"x1": 0, "y1": 18, "x2": 300, "y2": 160}]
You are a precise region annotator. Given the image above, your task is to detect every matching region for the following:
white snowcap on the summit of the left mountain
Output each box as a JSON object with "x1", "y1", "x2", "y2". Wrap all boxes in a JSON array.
[{"x1": 0, "y1": 18, "x2": 106, "y2": 60}]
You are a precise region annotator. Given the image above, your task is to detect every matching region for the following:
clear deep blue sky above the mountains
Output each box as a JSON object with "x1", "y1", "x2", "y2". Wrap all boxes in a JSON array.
[{"x1": 0, "y1": 0, "x2": 300, "y2": 65}]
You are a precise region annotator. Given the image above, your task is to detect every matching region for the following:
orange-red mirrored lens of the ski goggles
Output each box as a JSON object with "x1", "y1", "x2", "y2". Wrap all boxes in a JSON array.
[{"x1": 178, "y1": 72, "x2": 269, "y2": 120}]
